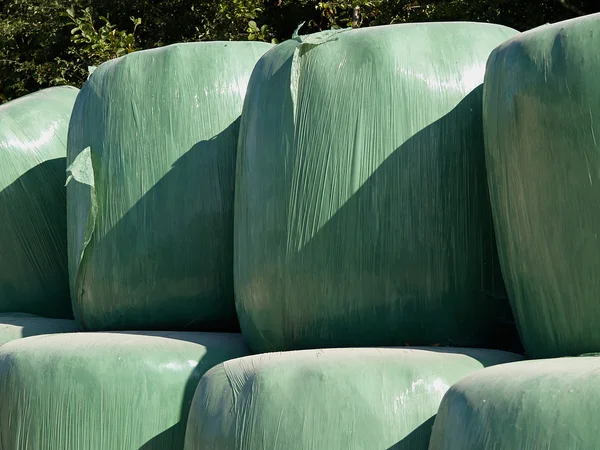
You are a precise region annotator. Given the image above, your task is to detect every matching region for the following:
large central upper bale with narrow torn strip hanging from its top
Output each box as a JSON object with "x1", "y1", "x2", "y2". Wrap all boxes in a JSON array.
[{"x1": 234, "y1": 23, "x2": 517, "y2": 352}]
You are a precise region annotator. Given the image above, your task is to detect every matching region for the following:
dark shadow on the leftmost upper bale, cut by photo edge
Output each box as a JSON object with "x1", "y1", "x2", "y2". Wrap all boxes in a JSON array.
[{"x1": 0, "y1": 158, "x2": 73, "y2": 319}]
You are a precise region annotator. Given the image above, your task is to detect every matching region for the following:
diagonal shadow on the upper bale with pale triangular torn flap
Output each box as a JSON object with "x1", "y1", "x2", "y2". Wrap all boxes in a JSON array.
[{"x1": 78, "y1": 118, "x2": 239, "y2": 332}]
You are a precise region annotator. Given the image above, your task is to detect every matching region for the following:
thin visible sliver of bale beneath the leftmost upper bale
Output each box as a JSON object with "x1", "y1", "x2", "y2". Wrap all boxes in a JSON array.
[{"x1": 0, "y1": 313, "x2": 80, "y2": 345}]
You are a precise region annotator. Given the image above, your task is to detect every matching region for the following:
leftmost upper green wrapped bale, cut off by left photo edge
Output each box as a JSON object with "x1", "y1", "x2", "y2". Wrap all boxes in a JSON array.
[{"x1": 0, "y1": 86, "x2": 79, "y2": 318}]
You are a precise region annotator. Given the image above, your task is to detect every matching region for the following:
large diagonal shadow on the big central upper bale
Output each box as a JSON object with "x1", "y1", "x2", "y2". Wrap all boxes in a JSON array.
[{"x1": 238, "y1": 85, "x2": 520, "y2": 352}]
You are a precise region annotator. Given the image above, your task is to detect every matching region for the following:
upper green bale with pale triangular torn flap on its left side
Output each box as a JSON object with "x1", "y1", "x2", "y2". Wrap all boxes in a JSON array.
[{"x1": 67, "y1": 42, "x2": 272, "y2": 331}]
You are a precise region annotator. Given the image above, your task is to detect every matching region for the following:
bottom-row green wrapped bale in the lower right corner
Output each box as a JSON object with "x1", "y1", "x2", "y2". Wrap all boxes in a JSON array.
[{"x1": 429, "y1": 357, "x2": 600, "y2": 450}]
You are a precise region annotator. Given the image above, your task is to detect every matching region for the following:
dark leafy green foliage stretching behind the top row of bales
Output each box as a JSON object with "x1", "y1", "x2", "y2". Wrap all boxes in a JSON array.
[{"x1": 0, "y1": 0, "x2": 600, "y2": 103}]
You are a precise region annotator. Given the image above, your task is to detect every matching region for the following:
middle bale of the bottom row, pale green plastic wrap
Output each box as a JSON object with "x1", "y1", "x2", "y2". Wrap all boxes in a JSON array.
[{"x1": 185, "y1": 348, "x2": 521, "y2": 450}]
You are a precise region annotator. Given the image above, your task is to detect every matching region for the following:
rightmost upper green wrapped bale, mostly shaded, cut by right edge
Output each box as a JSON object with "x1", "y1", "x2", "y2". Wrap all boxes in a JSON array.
[{"x1": 484, "y1": 14, "x2": 600, "y2": 358}]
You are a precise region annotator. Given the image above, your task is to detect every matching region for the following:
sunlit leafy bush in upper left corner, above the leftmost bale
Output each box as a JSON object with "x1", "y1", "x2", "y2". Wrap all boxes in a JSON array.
[{"x1": 0, "y1": 0, "x2": 141, "y2": 102}]
